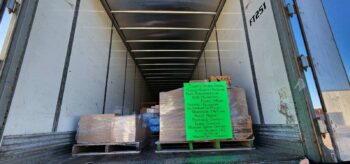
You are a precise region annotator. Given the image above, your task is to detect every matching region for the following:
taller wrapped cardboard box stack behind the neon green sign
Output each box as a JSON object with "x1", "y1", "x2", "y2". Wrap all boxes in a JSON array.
[{"x1": 159, "y1": 76, "x2": 253, "y2": 142}]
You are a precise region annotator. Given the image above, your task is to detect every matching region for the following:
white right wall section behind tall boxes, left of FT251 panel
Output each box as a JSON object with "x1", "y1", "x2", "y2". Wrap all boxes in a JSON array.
[{"x1": 193, "y1": 0, "x2": 260, "y2": 124}]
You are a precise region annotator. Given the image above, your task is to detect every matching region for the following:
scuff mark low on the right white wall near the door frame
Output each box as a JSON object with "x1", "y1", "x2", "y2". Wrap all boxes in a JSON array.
[{"x1": 278, "y1": 88, "x2": 295, "y2": 124}]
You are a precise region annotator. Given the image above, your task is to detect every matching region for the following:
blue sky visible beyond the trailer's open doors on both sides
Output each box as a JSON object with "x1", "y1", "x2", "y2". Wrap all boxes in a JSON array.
[{"x1": 0, "y1": 0, "x2": 350, "y2": 108}]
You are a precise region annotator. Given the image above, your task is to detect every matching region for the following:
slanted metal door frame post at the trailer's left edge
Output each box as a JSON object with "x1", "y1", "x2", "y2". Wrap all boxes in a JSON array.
[{"x1": 0, "y1": 0, "x2": 39, "y2": 141}]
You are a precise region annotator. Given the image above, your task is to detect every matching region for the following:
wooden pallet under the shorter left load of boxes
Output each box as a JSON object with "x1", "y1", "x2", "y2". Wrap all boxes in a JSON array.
[{"x1": 72, "y1": 142, "x2": 142, "y2": 156}]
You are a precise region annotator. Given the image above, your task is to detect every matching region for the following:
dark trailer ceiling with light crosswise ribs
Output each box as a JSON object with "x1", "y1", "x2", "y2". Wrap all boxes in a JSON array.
[{"x1": 101, "y1": 0, "x2": 225, "y2": 91}]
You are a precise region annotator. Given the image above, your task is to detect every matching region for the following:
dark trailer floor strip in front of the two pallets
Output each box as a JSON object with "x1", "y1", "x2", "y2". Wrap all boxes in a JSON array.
[{"x1": 51, "y1": 147, "x2": 303, "y2": 164}]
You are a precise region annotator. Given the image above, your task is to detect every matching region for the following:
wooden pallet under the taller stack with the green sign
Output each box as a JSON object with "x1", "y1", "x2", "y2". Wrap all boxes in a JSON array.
[{"x1": 156, "y1": 138, "x2": 255, "y2": 153}]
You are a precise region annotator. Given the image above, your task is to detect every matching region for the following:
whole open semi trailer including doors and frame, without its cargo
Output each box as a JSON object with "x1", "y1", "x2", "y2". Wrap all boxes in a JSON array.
[{"x1": 0, "y1": 0, "x2": 350, "y2": 163}]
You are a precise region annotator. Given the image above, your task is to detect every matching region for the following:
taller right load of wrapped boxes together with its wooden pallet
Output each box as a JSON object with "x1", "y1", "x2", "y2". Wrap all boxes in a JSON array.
[{"x1": 156, "y1": 80, "x2": 254, "y2": 153}]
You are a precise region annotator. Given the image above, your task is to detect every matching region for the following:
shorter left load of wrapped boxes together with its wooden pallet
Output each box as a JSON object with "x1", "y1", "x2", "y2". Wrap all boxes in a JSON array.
[{"x1": 72, "y1": 114, "x2": 145, "y2": 155}]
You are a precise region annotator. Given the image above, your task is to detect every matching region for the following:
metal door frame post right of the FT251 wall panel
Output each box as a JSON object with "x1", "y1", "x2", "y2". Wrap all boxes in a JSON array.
[{"x1": 271, "y1": 0, "x2": 326, "y2": 162}]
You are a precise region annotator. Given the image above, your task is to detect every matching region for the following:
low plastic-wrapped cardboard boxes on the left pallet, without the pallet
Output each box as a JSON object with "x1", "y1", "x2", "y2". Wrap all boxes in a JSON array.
[{"x1": 76, "y1": 114, "x2": 145, "y2": 144}]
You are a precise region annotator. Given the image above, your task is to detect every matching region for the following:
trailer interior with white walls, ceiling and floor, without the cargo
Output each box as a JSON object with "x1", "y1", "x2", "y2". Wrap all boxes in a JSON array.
[{"x1": 1, "y1": 0, "x2": 326, "y2": 163}]
